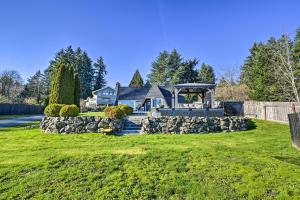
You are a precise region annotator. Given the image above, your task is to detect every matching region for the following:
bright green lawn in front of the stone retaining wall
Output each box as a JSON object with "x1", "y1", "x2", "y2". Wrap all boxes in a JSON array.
[{"x1": 0, "y1": 121, "x2": 300, "y2": 199}]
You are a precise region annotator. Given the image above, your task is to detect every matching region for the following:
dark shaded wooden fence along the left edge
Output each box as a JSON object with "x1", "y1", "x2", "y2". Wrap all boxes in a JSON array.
[{"x1": 0, "y1": 103, "x2": 44, "y2": 115}]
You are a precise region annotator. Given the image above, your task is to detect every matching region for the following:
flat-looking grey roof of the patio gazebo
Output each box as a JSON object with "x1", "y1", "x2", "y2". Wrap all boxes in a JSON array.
[{"x1": 173, "y1": 83, "x2": 216, "y2": 93}]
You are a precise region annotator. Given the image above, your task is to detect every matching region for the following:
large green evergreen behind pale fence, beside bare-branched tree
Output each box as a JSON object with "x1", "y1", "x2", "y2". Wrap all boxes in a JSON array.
[{"x1": 241, "y1": 38, "x2": 288, "y2": 101}]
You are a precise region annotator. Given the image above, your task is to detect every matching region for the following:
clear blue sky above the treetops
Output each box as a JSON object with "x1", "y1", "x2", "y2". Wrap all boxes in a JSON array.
[{"x1": 0, "y1": 0, "x2": 300, "y2": 86}]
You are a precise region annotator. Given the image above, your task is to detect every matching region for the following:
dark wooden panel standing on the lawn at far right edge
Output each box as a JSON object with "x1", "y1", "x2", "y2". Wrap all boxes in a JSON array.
[{"x1": 288, "y1": 113, "x2": 300, "y2": 150}]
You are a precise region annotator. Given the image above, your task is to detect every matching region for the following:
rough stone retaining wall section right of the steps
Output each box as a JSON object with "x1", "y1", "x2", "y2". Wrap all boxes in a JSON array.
[{"x1": 141, "y1": 116, "x2": 248, "y2": 134}]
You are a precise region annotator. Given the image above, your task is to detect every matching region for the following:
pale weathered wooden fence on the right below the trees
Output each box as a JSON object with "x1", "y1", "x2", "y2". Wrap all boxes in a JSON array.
[{"x1": 243, "y1": 101, "x2": 300, "y2": 123}]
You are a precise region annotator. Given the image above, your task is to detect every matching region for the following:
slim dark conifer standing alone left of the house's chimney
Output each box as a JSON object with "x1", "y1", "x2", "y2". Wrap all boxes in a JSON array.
[{"x1": 94, "y1": 56, "x2": 107, "y2": 90}]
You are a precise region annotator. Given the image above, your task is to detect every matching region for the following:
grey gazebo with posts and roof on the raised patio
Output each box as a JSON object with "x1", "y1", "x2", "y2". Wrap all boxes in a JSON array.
[{"x1": 172, "y1": 83, "x2": 216, "y2": 108}]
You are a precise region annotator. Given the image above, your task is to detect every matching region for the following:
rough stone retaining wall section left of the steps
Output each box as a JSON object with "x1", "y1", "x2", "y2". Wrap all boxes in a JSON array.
[{"x1": 40, "y1": 116, "x2": 123, "y2": 134}]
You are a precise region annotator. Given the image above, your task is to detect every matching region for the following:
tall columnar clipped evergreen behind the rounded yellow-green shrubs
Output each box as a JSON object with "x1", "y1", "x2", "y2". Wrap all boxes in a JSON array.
[{"x1": 49, "y1": 63, "x2": 75, "y2": 104}]
